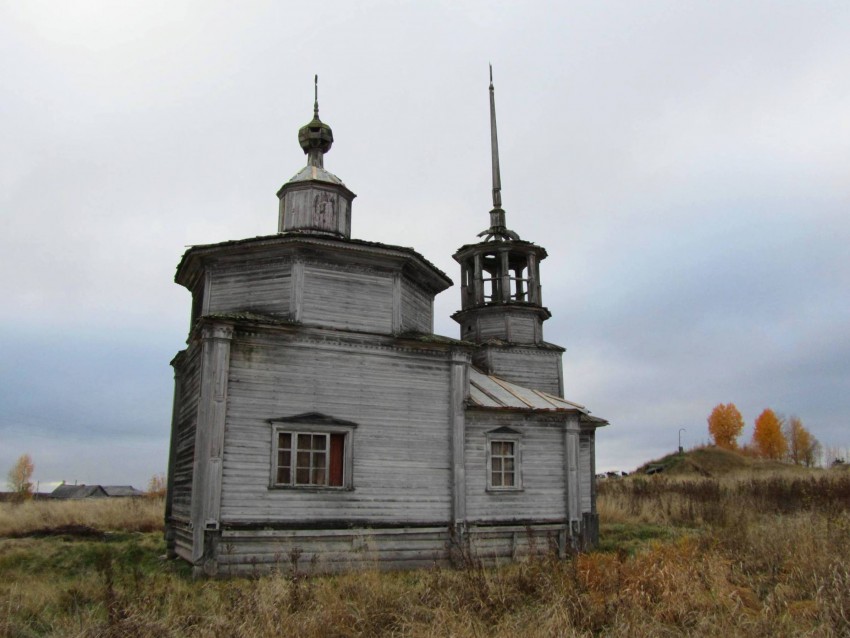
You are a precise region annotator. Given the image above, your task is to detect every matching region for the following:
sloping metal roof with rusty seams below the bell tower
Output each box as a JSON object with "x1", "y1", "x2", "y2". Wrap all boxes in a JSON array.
[{"x1": 469, "y1": 368, "x2": 607, "y2": 424}]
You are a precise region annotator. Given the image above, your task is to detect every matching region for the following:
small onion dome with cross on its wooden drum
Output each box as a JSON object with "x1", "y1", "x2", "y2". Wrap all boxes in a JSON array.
[{"x1": 277, "y1": 76, "x2": 356, "y2": 239}]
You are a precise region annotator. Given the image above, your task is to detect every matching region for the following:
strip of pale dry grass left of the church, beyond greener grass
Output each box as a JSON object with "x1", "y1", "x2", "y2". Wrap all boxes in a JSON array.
[{"x1": 0, "y1": 498, "x2": 164, "y2": 538}]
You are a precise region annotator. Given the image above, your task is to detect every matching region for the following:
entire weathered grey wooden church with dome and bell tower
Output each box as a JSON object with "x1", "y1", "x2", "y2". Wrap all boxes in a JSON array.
[{"x1": 166, "y1": 78, "x2": 606, "y2": 575}]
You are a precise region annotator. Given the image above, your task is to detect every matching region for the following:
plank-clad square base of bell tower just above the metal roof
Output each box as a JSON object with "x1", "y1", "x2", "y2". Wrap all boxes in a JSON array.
[{"x1": 473, "y1": 347, "x2": 562, "y2": 396}]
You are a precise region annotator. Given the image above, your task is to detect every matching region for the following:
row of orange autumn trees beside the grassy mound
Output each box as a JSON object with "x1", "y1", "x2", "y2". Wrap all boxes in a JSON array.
[{"x1": 708, "y1": 403, "x2": 824, "y2": 467}]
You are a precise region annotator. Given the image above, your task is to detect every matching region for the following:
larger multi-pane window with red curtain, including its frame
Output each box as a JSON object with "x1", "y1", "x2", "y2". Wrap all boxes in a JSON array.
[{"x1": 271, "y1": 414, "x2": 355, "y2": 488}]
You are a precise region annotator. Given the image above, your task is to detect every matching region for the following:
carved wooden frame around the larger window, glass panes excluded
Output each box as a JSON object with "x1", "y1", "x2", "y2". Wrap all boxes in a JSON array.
[{"x1": 268, "y1": 413, "x2": 357, "y2": 492}]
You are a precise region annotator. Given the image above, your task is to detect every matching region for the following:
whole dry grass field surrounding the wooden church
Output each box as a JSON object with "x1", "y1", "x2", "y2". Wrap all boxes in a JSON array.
[{"x1": 0, "y1": 452, "x2": 850, "y2": 638}]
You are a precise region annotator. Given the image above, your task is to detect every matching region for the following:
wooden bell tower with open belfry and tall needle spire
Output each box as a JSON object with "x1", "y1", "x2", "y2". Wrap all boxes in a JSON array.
[{"x1": 452, "y1": 66, "x2": 564, "y2": 396}]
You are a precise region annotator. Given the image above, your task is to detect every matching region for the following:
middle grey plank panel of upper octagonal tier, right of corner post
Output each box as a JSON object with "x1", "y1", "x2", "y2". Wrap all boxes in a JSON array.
[{"x1": 298, "y1": 264, "x2": 393, "y2": 333}]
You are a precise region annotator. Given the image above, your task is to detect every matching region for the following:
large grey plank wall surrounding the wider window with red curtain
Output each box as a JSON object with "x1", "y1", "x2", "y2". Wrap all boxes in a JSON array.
[{"x1": 221, "y1": 331, "x2": 458, "y2": 524}]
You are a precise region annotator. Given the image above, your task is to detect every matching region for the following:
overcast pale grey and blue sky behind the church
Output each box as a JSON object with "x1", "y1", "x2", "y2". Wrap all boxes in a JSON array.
[{"x1": 0, "y1": 0, "x2": 850, "y2": 488}]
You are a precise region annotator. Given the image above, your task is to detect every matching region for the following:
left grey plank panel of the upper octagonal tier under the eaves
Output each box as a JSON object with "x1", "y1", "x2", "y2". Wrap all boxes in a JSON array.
[{"x1": 207, "y1": 260, "x2": 292, "y2": 315}]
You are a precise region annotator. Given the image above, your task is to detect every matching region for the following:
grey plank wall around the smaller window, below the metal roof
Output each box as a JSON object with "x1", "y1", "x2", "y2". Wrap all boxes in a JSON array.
[{"x1": 466, "y1": 411, "x2": 566, "y2": 522}]
